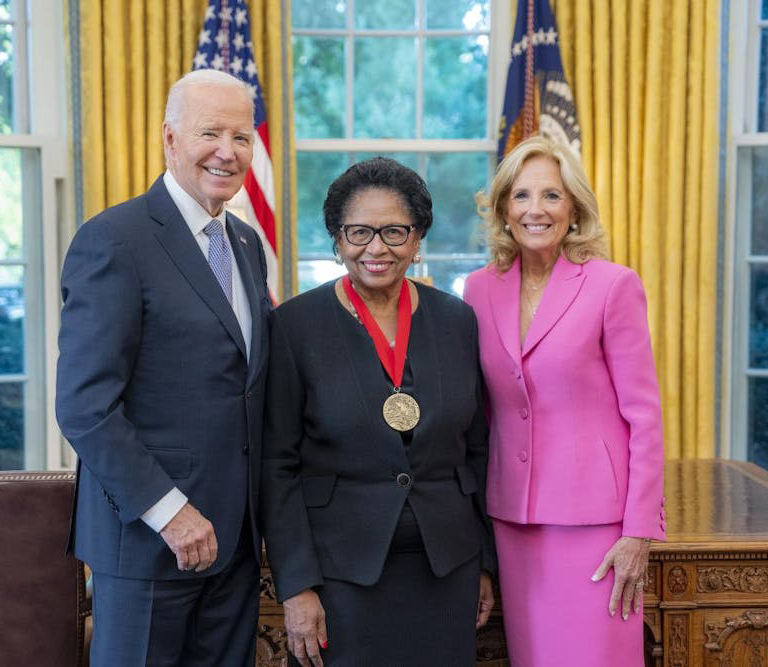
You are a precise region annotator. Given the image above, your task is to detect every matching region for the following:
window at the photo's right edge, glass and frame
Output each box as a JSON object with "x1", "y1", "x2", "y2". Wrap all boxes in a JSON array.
[{"x1": 729, "y1": 0, "x2": 768, "y2": 468}]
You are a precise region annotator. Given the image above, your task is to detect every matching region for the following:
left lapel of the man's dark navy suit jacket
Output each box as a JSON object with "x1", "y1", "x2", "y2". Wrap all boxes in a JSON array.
[{"x1": 147, "y1": 176, "x2": 247, "y2": 357}]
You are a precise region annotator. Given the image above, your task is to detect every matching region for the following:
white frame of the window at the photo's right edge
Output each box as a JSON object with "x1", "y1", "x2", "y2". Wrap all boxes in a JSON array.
[{"x1": 718, "y1": 0, "x2": 768, "y2": 461}]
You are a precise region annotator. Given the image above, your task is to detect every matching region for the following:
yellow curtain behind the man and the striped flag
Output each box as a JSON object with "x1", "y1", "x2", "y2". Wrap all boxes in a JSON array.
[{"x1": 69, "y1": 0, "x2": 296, "y2": 298}]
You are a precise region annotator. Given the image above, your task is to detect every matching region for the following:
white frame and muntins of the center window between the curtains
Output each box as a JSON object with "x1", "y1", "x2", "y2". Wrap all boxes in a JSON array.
[{"x1": 291, "y1": 0, "x2": 512, "y2": 292}]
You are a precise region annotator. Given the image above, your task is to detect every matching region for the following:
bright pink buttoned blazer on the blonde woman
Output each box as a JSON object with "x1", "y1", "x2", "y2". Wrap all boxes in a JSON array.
[{"x1": 464, "y1": 257, "x2": 666, "y2": 539}]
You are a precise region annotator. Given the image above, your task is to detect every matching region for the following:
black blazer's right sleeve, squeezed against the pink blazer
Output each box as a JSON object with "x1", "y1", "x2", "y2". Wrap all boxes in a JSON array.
[{"x1": 466, "y1": 314, "x2": 497, "y2": 575}]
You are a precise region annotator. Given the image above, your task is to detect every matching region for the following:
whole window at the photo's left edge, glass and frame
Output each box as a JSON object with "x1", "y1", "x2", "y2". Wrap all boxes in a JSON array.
[{"x1": 0, "y1": 0, "x2": 68, "y2": 470}]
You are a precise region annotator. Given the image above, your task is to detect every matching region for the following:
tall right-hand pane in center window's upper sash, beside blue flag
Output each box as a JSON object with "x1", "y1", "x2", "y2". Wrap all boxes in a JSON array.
[{"x1": 422, "y1": 35, "x2": 488, "y2": 139}]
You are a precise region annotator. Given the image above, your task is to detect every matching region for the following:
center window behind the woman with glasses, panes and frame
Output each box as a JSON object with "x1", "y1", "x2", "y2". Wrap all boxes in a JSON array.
[{"x1": 292, "y1": 0, "x2": 509, "y2": 294}]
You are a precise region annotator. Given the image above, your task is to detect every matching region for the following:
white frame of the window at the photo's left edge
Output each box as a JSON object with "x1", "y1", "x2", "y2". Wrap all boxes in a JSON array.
[{"x1": 0, "y1": 0, "x2": 73, "y2": 470}]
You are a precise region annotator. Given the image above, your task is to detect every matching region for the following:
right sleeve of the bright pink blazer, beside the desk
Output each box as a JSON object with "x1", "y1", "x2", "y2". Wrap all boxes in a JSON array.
[{"x1": 603, "y1": 269, "x2": 665, "y2": 540}]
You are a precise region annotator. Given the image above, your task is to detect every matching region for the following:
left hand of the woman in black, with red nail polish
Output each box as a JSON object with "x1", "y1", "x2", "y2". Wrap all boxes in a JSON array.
[{"x1": 283, "y1": 588, "x2": 328, "y2": 667}]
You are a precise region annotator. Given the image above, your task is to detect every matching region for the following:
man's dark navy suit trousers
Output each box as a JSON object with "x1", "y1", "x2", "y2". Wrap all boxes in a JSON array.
[{"x1": 91, "y1": 520, "x2": 259, "y2": 667}]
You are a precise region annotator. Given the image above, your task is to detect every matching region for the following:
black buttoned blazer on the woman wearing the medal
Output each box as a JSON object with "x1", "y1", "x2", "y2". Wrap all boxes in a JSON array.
[{"x1": 261, "y1": 282, "x2": 495, "y2": 601}]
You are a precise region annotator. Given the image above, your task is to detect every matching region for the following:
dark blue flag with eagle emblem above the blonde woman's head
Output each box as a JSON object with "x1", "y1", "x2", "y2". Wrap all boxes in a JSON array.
[{"x1": 498, "y1": 0, "x2": 581, "y2": 161}]
